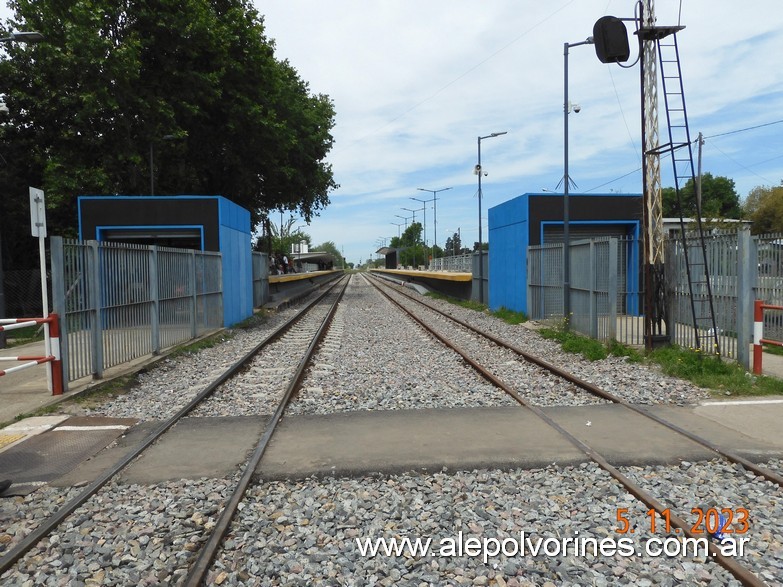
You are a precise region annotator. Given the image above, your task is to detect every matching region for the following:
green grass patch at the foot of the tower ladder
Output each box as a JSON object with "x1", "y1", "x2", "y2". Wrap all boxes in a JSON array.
[{"x1": 649, "y1": 346, "x2": 783, "y2": 395}]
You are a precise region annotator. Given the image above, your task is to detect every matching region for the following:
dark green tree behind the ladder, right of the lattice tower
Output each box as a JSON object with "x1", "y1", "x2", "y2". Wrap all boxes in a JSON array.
[{"x1": 662, "y1": 173, "x2": 742, "y2": 218}]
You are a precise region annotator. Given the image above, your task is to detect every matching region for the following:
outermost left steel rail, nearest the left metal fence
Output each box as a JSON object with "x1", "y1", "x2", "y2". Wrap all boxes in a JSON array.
[{"x1": 0, "y1": 281, "x2": 346, "y2": 574}]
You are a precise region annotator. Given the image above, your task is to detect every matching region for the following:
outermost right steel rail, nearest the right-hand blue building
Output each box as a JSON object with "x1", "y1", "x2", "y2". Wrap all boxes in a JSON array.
[{"x1": 370, "y1": 276, "x2": 783, "y2": 487}]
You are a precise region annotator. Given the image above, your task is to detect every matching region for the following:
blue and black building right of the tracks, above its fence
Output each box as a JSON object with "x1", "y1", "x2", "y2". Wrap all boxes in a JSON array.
[{"x1": 489, "y1": 193, "x2": 643, "y2": 313}]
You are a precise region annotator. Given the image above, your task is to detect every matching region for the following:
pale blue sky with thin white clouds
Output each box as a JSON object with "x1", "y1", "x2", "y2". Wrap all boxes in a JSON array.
[{"x1": 0, "y1": 0, "x2": 783, "y2": 263}]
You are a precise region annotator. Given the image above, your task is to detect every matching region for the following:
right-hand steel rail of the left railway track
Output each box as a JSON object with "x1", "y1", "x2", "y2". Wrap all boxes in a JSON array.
[{"x1": 184, "y1": 277, "x2": 350, "y2": 587}]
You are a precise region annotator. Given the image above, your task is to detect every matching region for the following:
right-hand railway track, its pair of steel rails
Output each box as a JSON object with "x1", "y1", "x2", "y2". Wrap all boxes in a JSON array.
[{"x1": 371, "y1": 278, "x2": 783, "y2": 586}]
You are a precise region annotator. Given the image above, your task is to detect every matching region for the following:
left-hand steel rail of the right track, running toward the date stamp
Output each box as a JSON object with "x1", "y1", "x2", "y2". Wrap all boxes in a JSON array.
[{"x1": 373, "y1": 276, "x2": 766, "y2": 587}]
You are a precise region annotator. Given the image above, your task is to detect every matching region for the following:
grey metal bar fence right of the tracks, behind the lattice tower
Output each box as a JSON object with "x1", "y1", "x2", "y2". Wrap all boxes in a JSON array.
[{"x1": 527, "y1": 228, "x2": 783, "y2": 368}]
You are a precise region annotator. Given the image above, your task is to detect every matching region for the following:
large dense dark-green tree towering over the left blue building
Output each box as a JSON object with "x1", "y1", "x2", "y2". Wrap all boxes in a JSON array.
[{"x1": 0, "y1": 0, "x2": 337, "y2": 270}]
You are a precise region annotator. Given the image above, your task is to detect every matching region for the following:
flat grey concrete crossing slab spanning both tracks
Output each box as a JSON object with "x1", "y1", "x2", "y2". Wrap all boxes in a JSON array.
[{"x1": 6, "y1": 404, "x2": 783, "y2": 486}]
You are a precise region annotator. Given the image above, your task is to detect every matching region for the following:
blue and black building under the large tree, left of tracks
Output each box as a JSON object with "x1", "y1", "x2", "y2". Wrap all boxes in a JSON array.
[{"x1": 78, "y1": 196, "x2": 253, "y2": 326}]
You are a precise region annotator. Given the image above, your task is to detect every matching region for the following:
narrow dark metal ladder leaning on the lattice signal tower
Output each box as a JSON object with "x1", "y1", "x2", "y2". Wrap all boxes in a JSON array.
[{"x1": 656, "y1": 32, "x2": 720, "y2": 354}]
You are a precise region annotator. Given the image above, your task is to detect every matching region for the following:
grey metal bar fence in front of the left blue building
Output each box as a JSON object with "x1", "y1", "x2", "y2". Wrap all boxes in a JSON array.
[{"x1": 51, "y1": 237, "x2": 223, "y2": 385}]
